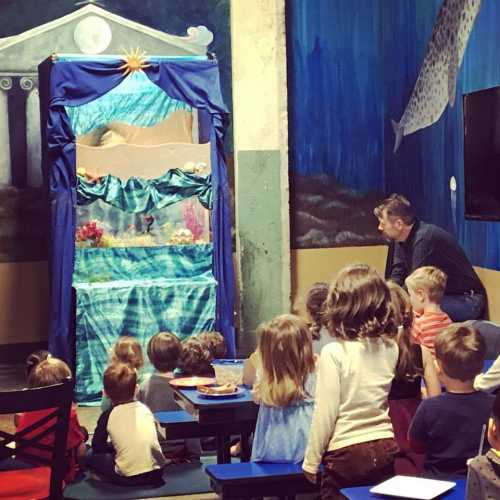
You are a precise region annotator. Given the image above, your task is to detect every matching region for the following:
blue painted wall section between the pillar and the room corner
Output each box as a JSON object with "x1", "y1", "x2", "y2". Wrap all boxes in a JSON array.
[{"x1": 287, "y1": 0, "x2": 384, "y2": 192}]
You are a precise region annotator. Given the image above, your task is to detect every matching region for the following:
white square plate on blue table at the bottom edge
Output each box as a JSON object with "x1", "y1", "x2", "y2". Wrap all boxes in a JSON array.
[{"x1": 370, "y1": 476, "x2": 456, "y2": 500}]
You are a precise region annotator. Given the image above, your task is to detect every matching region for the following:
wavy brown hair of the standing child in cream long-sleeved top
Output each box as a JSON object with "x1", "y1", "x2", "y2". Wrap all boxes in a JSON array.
[{"x1": 325, "y1": 264, "x2": 397, "y2": 340}]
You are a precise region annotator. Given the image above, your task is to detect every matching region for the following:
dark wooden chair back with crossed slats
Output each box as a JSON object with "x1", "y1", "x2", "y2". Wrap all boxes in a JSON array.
[{"x1": 0, "y1": 378, "x2": 73, "y2": 499}]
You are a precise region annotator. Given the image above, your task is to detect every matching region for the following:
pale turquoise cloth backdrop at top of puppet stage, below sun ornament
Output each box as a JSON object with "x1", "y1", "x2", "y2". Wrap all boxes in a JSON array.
[{"x1": 65, "y1": 71, "x2": 191, "y2": 135}]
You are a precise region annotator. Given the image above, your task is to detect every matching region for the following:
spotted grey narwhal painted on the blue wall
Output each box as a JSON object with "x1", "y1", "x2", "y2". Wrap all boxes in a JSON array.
[{"x1": 392, "y1": 0, "x2": 481, "y2": 153}]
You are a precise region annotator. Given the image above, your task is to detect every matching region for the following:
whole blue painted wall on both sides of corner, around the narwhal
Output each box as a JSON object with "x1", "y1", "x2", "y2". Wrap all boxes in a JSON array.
[{"x1": 287, "y1": 0, "x2": 500, "y2": 269}]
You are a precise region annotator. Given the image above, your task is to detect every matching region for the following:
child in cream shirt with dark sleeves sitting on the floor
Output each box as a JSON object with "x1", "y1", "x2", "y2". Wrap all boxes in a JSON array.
[{"x1": 88, "y1": 363, "x2": 165, "y2": 486}]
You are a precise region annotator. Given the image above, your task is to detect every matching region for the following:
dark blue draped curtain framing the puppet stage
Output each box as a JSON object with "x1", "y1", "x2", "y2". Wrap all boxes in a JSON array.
[{"x1": 45, "y1": 58, "x2": 235, "y2": 364}]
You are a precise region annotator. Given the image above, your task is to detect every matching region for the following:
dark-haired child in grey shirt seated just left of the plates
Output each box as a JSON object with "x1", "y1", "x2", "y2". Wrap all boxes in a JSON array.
[{"x1": 137, "y1": 332, "x2": 201, "y2": 463}]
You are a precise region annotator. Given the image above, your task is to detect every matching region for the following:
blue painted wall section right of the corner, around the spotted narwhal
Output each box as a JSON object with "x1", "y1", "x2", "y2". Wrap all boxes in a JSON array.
[{"x1": 378, "y1": 0, "x2": 500, "y2": 269}]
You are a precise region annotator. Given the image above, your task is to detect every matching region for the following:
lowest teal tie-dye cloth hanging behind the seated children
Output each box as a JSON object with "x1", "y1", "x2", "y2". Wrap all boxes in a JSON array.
[{"x1": 75, "y1": 277, "x2": 217, "y2": 402}]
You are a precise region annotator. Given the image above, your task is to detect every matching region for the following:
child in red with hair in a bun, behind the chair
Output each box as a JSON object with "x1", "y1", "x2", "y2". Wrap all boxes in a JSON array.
[{"x1": 16, "y1": 356, "x2": 86, "y2": 482}]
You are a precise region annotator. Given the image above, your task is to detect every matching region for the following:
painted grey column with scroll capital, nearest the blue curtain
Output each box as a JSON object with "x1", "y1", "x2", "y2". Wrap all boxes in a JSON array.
[{"x1": 20, "y1": 77, "x2": 43, "y2": 187}]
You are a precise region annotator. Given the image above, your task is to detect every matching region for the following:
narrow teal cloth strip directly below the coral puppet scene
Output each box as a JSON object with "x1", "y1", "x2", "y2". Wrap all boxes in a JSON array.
[{"x1": 73, "y1": 244, "x2": 213, "y2": 285}]
